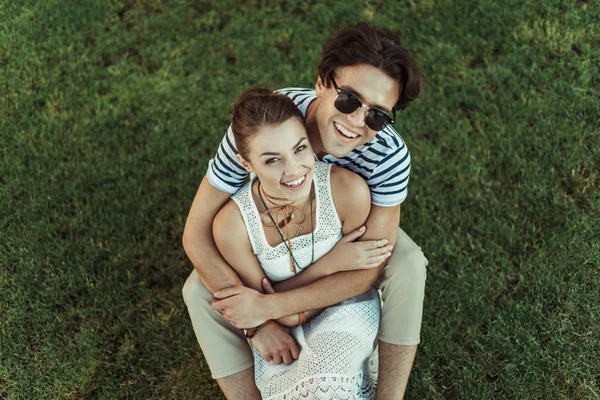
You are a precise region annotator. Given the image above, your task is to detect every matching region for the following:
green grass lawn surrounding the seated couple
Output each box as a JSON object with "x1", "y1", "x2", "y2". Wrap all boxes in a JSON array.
[{"x1": 0, "y1": 0, "x2": 600, "y2": 399}]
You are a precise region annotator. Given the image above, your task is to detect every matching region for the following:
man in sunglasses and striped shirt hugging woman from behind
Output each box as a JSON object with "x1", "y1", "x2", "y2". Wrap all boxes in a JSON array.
[{"x1": 183, "y1": 24, "x2": 427, "y2": 399}]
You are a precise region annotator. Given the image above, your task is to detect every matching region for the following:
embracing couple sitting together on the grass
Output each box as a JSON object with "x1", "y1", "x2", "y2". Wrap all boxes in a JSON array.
[{"x1": 183, "y1": 24, "x2": 427, "y2": 399}]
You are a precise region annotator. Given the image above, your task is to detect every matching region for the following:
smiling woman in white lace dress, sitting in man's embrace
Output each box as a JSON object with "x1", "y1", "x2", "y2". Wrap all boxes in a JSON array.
[{"x1": 213, "y1": 89, "x2": 391, "y2": 399}]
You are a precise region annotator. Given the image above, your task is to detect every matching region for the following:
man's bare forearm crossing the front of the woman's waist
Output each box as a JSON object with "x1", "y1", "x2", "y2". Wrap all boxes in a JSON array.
[{"x1": 265, "y1": 267, "x2": 382, "y2": 319}]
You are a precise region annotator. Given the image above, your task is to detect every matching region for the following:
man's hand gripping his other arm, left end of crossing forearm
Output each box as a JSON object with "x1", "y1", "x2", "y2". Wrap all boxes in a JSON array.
[{"x1": 211, "y1": 286, "x2": 271, "y2": 329}]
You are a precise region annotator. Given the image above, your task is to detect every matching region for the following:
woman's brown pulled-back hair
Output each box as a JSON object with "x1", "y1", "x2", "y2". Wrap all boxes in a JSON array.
[{"x1": 231, "y1": 88, "x2": 306, "y2": 160}]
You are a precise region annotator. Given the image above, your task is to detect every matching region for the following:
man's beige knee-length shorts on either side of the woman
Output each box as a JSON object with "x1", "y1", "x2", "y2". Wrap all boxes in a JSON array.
[{"x1": 183, "y1": 229, "x2": 427, "y2": 379}]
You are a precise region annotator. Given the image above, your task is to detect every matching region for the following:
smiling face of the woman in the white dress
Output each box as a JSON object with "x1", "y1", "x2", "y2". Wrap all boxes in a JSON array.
[{"x1": 238, "y1": 118, "x2": 315, "y2": 203}]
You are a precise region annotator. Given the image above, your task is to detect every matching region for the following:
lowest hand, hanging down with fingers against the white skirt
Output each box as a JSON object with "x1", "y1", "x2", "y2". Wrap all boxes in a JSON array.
[{"x1": 252, "y1": 322, "x2": 300, "y2": 365}]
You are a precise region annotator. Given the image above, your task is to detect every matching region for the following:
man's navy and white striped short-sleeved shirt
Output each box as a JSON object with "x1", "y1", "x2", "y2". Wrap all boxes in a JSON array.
[{"x1": 206, "y1": 88, "x2": 410, "y2": 207}]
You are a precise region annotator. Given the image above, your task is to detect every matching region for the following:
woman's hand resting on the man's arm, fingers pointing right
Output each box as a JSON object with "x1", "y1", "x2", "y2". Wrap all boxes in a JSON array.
[{"x1": 325, "y1": 226, "x2": 394, "y2": 274}]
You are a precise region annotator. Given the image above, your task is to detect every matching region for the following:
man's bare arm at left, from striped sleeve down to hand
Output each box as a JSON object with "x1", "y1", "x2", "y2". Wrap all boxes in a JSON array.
[{"x1": 182, "y1": 177, "x2": 242, "y2": 293}]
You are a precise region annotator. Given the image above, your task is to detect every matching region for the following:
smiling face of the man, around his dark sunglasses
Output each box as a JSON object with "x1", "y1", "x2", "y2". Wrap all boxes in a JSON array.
[{"x1": 315, "y1": 64, "x2": 400, "y2": 158}]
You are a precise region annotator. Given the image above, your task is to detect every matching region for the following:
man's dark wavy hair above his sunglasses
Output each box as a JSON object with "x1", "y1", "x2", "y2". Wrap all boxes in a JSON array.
[{"x1": 317, "y1": 23, "x2": 420, "y2": 110}]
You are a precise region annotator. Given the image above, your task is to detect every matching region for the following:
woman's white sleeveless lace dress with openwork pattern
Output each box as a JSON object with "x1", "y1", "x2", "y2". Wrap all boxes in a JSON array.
[{"x1": 233, "y1": 162, "x2": 380, "y2": 400}]
